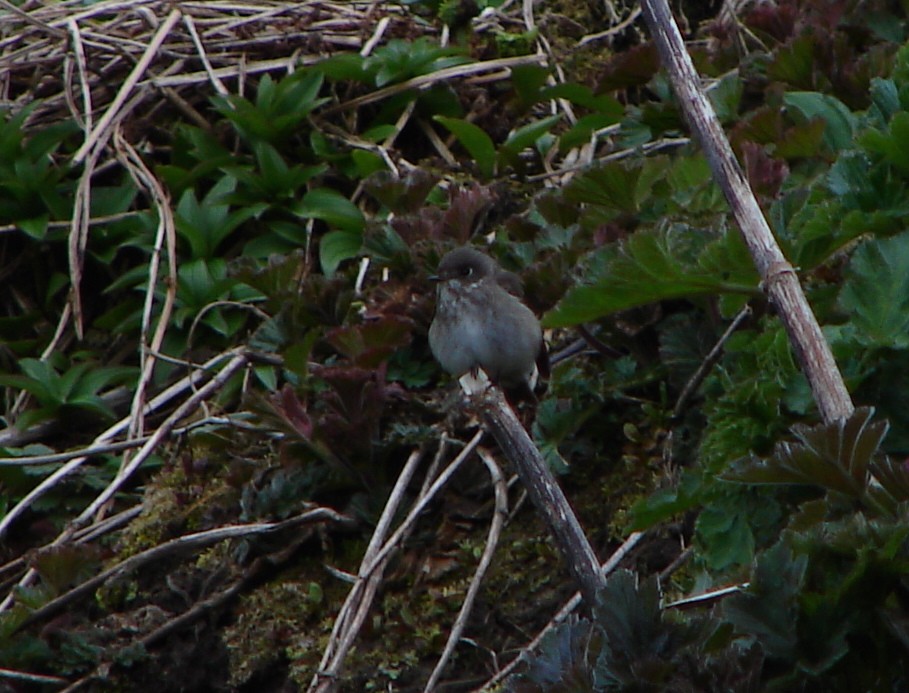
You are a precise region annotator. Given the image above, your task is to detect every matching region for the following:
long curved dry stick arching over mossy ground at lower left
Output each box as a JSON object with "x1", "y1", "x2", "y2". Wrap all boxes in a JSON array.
[{"x1": 15, "y1": 508, "x2": 353, "y2": 631}]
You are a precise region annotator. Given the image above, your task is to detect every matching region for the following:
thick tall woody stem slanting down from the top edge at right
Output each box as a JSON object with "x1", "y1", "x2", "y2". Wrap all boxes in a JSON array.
[{"x1": 641, "y1": 0, "x2": 854, "y2": 422}]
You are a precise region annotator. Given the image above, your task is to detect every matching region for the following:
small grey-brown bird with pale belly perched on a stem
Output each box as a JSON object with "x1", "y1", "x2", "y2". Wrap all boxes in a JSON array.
[{"x1": 429, "y1": 246, "x2": 548, "y2": 402}]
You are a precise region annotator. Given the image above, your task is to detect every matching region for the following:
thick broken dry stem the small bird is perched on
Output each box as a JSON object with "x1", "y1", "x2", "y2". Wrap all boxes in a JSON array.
[{"x1": 461, "y1": 371, "x2": 605, "y2": 607}]
